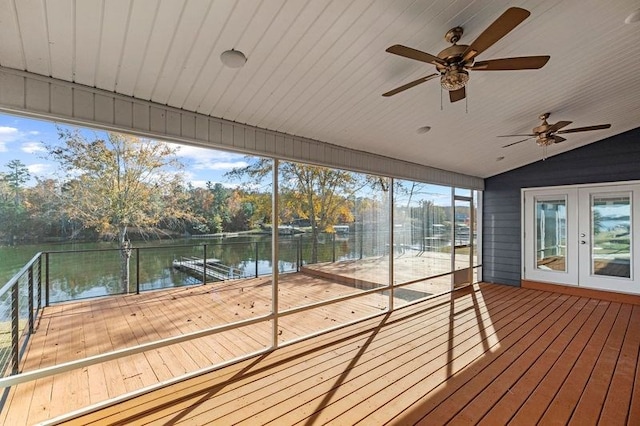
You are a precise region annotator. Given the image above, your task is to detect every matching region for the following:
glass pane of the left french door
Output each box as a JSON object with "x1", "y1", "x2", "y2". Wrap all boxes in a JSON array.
[{"x1": 535, "y1": 197, "x2": 567, "y2": 271}]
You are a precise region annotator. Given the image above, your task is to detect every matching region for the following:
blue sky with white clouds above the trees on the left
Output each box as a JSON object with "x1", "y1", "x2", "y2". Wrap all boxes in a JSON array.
[{"x1": 0, "y1": 114, "x2": 247, "y2": 187}]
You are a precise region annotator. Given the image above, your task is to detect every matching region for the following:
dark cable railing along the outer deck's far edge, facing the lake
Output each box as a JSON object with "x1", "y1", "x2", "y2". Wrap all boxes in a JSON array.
[{"x1": 42, "y1": 240, "x2": 302, "y2": 306}]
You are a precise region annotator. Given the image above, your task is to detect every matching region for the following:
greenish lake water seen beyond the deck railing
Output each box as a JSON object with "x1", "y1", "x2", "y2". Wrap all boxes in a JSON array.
[{"x1": 0, "y1": 235, "x2": 375, "y2": 302}]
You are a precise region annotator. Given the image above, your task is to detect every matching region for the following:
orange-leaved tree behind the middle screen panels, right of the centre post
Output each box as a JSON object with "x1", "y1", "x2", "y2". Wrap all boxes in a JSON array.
[{"x1": 228, "y1": 159, "x2": 363, "y2": 262}]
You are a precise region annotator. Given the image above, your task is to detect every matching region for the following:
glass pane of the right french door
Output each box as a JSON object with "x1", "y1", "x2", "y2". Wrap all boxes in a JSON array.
[{"x1": 591, "y1": 194, "x2": 631, "y2": 278}]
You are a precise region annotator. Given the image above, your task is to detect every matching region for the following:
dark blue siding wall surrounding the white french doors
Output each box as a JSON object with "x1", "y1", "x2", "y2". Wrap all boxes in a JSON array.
[{"x1": 482, "y1": 128, "x2": 640, "y2": 285}]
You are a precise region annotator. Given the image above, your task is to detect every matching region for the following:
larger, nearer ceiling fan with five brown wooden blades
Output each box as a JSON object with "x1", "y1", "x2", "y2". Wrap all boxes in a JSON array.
[{"x1": 382, "y1": 7, "x2": 549, "y2": 102}]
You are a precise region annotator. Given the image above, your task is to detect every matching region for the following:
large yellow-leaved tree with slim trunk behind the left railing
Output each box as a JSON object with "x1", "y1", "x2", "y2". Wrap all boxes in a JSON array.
[{"x1": 46, "y1": 128, "x2": 190, "y2": 291}]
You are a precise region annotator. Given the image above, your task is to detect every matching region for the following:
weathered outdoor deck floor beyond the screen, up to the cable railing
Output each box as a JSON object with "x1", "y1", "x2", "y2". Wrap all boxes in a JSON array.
[{"x1": 0, "y1": 274, "x2": 400, "y2": 425}]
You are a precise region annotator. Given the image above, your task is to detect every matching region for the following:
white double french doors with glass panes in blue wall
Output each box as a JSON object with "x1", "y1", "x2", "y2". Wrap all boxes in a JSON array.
[{"x1": 523, "y1": 183, "x2": 640, "y2": 294}]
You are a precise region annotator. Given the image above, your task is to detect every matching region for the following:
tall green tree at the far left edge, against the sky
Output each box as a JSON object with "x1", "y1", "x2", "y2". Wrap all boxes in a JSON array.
[{"x1": 0, "y1": 160, "x2": 31, "y2": 245}]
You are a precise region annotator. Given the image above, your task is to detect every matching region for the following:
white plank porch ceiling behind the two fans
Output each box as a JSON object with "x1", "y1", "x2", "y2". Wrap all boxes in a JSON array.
[{"x1": 0, "y1": 0, "x2": 640, "y2": 177}]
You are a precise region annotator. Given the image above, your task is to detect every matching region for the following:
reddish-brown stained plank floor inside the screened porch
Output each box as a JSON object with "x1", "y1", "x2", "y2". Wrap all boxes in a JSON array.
[{"x1": 43, "y1": 284, "x2": 640, "y2": 425}]
